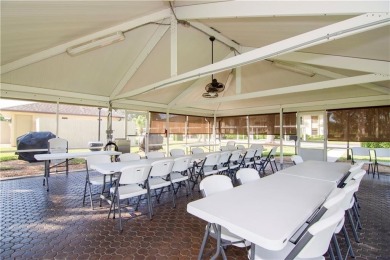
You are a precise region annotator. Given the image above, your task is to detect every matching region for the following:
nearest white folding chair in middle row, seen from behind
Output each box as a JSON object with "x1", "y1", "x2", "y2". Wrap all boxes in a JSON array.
[{"x1": 108, "y1": 164, "x2": 152, "y2": 231}]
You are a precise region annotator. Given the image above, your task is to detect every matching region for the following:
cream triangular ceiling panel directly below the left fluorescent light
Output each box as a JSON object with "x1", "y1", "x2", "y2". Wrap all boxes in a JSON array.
[{"x1": 2, "y1": 25, "x2": 161, "y2": 96}]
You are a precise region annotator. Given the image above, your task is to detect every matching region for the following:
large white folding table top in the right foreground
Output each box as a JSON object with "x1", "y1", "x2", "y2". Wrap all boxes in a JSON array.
[{"x1": 187, "y1": 174, "x2": 336, "y2": 258}]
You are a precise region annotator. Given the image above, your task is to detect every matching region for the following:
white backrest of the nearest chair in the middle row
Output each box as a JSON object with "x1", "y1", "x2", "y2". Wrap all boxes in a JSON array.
[{"x1": 119, "y1": 164, "x2": 150, "y2": 184}]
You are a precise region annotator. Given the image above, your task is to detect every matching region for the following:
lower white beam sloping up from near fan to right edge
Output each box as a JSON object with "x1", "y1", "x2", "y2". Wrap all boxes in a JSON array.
[{"x1": 183, "y1": 74, "x2": 390, "y2": 105}]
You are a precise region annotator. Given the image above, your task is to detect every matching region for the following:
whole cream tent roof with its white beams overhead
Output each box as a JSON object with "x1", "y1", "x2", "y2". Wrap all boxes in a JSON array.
[{"x1": 1, "y1": 1, "x2": 390, "y2": 116}]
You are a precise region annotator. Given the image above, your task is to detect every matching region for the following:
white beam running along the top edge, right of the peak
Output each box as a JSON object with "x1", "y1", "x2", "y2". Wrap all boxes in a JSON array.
[{"x1": 175, "y1": 0, "x2": 389, "y2": 20}]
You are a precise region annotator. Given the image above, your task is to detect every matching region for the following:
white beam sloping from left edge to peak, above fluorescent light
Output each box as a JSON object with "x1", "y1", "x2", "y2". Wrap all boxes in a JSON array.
[{"x1": 0, "y1": 9, "x2": 171, "y2": 74}]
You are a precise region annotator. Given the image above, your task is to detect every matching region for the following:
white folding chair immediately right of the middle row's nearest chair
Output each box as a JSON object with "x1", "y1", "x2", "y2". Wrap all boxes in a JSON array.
[{"x1": 147, "y1": 159, "x2": 176, "y2": 216}]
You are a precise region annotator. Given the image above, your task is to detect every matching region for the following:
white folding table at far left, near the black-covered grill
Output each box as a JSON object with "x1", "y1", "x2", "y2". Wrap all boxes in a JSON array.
[{"x1": 34, "y1": 151, "x2": 121, "y2": 191}]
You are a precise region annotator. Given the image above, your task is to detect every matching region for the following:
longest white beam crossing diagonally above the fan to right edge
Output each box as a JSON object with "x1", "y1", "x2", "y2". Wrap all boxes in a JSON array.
[{"x1": 115, "y1": 13, "x2": 390, "y2": 99}]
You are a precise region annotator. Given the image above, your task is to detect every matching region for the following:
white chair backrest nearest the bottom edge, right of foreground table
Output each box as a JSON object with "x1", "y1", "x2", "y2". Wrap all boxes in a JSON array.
[{"x1": 296, "y1": 209, "x2": 344, "y2": 258}]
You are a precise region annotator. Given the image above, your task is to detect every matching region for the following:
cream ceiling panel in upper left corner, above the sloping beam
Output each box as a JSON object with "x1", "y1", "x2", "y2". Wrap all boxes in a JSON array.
[{"x1": 1, "y1": 1, "x2": 167, "y2": 65}]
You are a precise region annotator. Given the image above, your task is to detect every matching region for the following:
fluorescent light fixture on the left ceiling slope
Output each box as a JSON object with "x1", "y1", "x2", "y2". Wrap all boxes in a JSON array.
[{"x1": 66, "y1": 32, "x2": 125, "y2": 56}]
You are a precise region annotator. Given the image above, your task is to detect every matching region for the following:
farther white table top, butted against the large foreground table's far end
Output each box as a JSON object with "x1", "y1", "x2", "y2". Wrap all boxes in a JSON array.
[{"x1": 276, "y1": 161, "x2": 351, "y2": 183}]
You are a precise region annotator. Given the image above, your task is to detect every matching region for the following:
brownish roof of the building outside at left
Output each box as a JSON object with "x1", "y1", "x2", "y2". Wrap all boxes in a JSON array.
[{"x1": 1, "y1": 103, "x2": 124, "y2": 117}]
